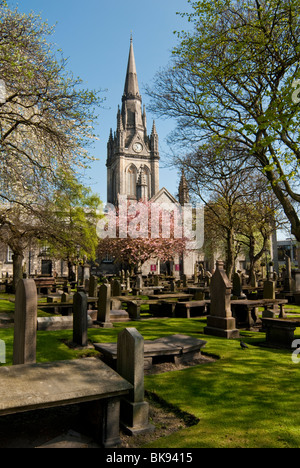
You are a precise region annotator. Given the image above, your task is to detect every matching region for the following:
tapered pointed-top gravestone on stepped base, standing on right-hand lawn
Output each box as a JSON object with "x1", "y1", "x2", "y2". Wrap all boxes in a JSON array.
[{"x1": 204, "y1": 261, "x2": 239, "y2": 338}]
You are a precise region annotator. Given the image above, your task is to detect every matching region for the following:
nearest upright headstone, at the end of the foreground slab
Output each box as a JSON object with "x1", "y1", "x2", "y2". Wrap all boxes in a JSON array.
[{"x1": 117, "y1": 328, "x2": 153, "y2": 435}]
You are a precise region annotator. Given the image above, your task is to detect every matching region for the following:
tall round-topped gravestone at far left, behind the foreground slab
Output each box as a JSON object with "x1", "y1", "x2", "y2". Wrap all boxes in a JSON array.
[{"x1": 13, "y1": 279, "x2": 37, "y2": 366}]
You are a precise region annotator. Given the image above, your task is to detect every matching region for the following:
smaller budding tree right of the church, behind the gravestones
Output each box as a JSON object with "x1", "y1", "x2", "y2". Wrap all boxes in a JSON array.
[{"x1": 176, "y1": 140, "x2": 280, "y2": 278}]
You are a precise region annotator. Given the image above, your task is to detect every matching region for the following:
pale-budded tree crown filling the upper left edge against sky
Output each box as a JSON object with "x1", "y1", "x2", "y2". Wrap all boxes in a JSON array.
[{"x1": 0, "y1": 2, "x2": 102, "y2": 206}]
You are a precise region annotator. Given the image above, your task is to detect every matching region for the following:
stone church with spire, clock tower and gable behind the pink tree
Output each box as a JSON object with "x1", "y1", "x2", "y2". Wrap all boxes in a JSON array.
[{"x1": 102, "y1": 38, "x2": 203, "y2": 275}]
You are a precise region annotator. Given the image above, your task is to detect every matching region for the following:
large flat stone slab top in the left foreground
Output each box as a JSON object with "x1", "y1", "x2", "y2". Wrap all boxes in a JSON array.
[{"x1": 0, "y1": 358, "x2": 132, "y2": 416}]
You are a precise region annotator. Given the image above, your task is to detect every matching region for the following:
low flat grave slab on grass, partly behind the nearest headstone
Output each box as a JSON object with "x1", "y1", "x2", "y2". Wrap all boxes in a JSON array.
[{"x1": 94, "y1": 335, "x2": 207, "y2": 369}]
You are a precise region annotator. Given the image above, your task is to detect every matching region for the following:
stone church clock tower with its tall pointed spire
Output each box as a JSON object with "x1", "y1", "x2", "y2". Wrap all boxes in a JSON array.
[{"x1": 106, "y1": 38, "x2": 159, "y2": 205}]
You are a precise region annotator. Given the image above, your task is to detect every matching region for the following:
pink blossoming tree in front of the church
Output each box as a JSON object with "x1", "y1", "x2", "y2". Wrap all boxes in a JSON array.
[{"x1": 98, "y1": 201, "x2": 187, "y2": 271}]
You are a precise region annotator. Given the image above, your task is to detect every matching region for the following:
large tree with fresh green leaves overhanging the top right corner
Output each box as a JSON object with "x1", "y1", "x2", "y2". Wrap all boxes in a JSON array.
[{"x1": 149, "y1": 0, "x2": 300, "y2": 241}]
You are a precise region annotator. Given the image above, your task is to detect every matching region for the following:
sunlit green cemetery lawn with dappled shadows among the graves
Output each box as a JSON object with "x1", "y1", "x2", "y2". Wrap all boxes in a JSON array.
[{"x1": 0, "y1": 309, "x2": 300, "y2": 448}]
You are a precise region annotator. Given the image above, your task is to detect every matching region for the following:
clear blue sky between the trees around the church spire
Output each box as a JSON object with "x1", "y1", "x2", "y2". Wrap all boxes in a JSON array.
[{"x1": 12, "y1": 0, "x2": 190, "y2": 202}]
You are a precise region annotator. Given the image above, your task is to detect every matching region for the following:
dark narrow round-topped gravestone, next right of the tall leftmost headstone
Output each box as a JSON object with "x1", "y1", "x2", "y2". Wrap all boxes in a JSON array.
[{"x1": 73, "y1": 292, "x2": 88, "y2": 347}]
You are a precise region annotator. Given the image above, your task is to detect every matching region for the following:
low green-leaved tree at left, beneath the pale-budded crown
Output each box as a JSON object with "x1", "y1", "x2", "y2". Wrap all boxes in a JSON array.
[{"x1": 0, "y1": 173, "x2": 102, "y2": 289}]
